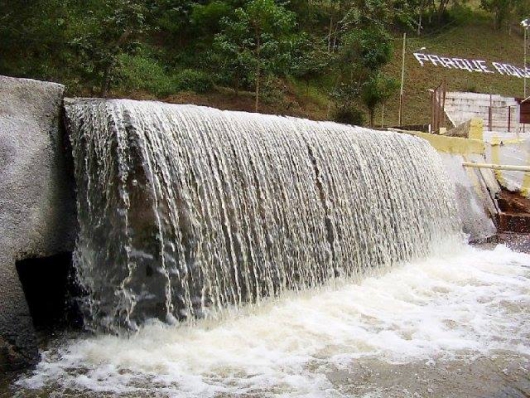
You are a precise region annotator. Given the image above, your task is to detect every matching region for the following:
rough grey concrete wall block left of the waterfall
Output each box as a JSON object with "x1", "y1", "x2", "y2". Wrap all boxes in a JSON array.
[{"x1": 0, "y1": 76, "x2": 76, "y2": 370}]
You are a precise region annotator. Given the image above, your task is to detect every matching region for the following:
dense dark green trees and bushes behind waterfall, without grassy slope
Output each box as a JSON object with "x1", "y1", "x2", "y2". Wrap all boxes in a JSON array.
[{"x1": 0, "y1": 0, "x2": 526, "y2": 123}]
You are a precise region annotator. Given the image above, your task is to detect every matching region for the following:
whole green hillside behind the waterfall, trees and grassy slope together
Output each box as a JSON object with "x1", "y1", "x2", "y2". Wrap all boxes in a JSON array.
[{"x1": 0, "y1": 0, "x2": 530, "y2": 125}]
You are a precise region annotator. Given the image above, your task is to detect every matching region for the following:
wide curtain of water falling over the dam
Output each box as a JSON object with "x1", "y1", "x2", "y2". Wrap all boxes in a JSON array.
[{"x1": 66, "y1": 100, "x2": 460, "y2": 331}]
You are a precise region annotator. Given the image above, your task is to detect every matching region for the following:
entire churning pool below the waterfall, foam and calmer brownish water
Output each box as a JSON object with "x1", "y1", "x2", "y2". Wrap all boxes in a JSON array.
[{"x1": 4, "y1": 244, "x2": 530, "y2": 397}]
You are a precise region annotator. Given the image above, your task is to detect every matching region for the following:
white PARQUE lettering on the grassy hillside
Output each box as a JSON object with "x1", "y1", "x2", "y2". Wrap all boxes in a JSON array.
[{"x1": 414, "y1": 53, "x2": 530, "y2": 78}]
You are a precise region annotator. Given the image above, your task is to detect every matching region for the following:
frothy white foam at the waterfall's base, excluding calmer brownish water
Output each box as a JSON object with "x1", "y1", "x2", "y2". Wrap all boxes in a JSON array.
[{"x1": 19, "y1": 245, "x2": 530, "y2": 397}]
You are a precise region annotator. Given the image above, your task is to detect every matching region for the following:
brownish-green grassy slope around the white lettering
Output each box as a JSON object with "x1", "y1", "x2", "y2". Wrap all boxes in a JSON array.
[{"x1": 384, "y1": 14, "x2": 530, "y2": 125}]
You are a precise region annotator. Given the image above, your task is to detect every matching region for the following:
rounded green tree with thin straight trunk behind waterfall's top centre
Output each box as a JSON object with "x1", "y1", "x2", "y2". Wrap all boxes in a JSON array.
[{"x1": 215, "y1": 0, "x2": 294, "y2": 112}]
